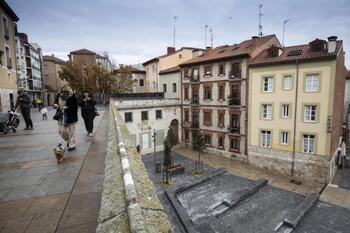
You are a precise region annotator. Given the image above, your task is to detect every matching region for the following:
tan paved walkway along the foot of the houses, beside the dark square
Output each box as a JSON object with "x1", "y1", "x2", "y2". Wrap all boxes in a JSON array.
[{"x1": 174, "y1": 145, "x2": 324, "y2": 195}]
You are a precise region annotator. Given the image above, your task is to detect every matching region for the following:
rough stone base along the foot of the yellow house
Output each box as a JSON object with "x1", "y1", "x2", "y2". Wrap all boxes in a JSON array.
[{"x1": 248, "y1": 146, "x2": 329, "y2": 183}]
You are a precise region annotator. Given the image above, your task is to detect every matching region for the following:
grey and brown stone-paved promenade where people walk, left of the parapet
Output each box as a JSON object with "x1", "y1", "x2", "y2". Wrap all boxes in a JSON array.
[{"x1": 0, "y1": 109, "x2": 107, "y2": 233}]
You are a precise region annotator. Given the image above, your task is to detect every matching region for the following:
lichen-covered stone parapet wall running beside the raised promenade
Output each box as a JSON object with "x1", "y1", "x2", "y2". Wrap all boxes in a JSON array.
[{"x1": 96, "y1": 104, "x2": 171, "y2": 233}]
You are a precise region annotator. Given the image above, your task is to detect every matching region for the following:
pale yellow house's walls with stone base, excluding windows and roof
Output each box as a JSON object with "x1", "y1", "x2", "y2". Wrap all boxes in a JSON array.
[{"x1": 248, "y1": 59, "x2": 341, "y2": 182}]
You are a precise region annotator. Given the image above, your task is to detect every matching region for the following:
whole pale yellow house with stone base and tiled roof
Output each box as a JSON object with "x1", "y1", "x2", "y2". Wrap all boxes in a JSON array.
[{"x1": 248, "y1": 36, "x2": 346, "y2": 182}]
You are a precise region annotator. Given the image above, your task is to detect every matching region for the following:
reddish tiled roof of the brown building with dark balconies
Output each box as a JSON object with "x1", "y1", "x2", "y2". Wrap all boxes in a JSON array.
[{"x1": 180, "y1": 34, "x2": 275, "y2": 66}]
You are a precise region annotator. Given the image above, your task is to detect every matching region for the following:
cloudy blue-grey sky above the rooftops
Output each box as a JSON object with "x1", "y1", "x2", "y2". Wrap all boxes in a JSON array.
[{"x1": 6, "y1": 0, "x2": 350, "y2": 68}]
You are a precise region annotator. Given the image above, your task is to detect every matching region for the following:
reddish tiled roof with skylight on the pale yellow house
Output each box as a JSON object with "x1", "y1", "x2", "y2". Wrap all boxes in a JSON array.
[{"x1": 249, "y1": 41, "x2": 343, "y2": 66}]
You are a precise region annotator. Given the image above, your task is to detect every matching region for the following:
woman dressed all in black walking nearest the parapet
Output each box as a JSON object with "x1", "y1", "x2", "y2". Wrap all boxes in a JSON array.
[{"x1": 79, "y1": 90, "x2": 96, "y2": 137}]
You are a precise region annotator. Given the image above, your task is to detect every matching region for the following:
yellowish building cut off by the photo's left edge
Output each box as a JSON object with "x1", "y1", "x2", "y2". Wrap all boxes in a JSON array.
[{"x1": 0, "y1": 0, "x2": 19, "y2": 112}]
